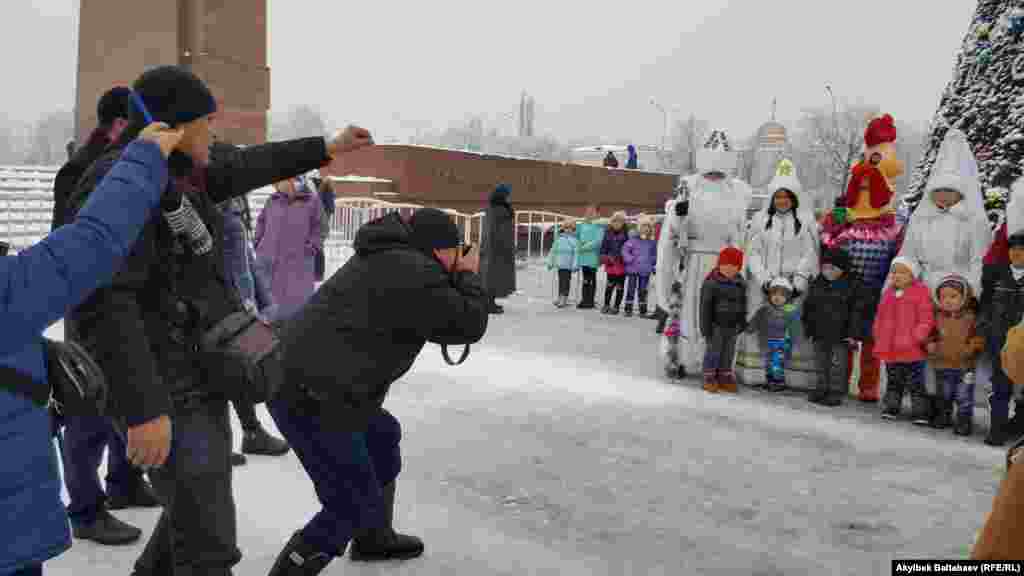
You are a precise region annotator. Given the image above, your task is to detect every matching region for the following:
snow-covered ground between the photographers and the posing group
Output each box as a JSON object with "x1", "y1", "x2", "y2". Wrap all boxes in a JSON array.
[{"x1": 47, "y1": 262, "x2": 1004, "y2": 576}]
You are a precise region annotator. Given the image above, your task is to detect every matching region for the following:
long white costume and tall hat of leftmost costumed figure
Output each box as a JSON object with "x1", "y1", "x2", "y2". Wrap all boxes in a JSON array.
[{"x1": 656, "y1": 130, "x2": 753, "y2": 378}]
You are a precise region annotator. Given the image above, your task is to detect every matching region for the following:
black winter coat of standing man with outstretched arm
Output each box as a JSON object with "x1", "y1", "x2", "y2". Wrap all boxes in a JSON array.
[{"x1": 71, "y1": 138, "x2": 328, "y2": 426}]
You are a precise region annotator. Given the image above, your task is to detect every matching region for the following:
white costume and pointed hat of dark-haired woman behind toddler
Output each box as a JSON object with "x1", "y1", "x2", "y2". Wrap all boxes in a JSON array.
[{"x1": 736, "y1": 160, "x2": 818, "y2": 388}]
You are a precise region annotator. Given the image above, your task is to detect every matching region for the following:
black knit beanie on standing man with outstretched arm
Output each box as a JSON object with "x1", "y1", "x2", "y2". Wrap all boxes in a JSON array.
[{"x1": 132, "y1": 66, "x2": 217, "y2": 127}]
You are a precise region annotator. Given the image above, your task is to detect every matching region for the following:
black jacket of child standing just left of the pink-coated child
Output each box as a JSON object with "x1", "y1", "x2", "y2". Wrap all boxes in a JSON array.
[{"x1": 801, "y1": 272, "x2": 874, "y2": 343}]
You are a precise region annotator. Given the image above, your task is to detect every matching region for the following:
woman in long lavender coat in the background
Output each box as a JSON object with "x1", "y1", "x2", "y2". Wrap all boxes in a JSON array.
[{"x1": 255, "y1": 179, "x2": 324, "y2": 320}]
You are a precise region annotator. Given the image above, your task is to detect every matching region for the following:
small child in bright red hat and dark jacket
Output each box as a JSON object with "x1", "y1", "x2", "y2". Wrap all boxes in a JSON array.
[{"x1": 700, "y1": 246, "x2": 746, "y2": 394}]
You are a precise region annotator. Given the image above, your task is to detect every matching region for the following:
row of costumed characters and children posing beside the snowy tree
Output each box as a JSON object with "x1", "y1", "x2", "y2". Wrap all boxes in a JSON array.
[{"x1": 655, "y1": 115, "x2": 1024, "y2": 446}]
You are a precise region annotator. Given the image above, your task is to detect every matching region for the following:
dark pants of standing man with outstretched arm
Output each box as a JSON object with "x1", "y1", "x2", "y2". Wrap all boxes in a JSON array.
[{"x1": 135, "y1": 399, "x2": 242, "y2": 576}]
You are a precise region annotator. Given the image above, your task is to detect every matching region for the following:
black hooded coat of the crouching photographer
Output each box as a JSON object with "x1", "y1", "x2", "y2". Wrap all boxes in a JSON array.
[{"x1": 282, "y1": 214, "x2": 488, "y2": 431}]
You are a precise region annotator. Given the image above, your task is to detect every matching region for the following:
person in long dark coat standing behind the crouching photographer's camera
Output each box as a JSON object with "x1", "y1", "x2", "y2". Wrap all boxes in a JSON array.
[{"x1": 480, "y1": 184, "x2": 515, "y2": 314}]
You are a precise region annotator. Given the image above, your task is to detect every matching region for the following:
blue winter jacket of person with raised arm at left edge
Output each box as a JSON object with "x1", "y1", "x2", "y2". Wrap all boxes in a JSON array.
[{"x1": 0, "y1": 141, "x2": 167, "y2": 574}]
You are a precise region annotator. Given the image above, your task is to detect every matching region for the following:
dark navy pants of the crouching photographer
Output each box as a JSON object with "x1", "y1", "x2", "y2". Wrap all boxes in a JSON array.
[{"x1": 267, "y1": 389, "x2": 401, "y2": 556}]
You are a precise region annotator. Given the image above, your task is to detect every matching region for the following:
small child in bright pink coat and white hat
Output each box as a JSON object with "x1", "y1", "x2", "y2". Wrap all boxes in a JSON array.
[{"x1": 873, "y1": 257, "x2": 935, "y2": 426}]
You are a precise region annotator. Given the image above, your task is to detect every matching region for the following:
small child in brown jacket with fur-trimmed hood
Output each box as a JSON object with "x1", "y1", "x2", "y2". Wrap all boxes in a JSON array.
[{"x1": 926, "y1": 275, "x2": 985, "y2": 436}]
